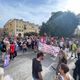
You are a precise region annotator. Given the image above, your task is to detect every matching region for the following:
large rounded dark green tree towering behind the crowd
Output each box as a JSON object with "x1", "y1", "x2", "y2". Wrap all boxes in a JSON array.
[{"x1": 40, "y1": 11, "x2": 78, "y2": 37}]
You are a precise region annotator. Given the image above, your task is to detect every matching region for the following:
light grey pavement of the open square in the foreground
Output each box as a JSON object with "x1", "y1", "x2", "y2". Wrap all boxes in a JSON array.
[{"x1": 0, "y1": 51, "x2": 76, "y2": 80}]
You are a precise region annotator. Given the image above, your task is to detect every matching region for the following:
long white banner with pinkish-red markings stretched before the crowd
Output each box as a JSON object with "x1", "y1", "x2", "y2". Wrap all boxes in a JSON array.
[{"x1": 38, "y1": 42, "x2": 60, "y2": 56}]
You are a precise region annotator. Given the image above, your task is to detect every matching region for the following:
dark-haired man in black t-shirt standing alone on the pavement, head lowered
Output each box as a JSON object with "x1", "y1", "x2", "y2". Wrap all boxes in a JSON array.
[{"x1": 32, "y1": 52, "x2": 44, "y2": 80}]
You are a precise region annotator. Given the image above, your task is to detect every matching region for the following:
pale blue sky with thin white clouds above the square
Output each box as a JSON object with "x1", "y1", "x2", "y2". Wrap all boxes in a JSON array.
[{"x1": 0, "y1": 0, "x2": 80, "y2": 27}]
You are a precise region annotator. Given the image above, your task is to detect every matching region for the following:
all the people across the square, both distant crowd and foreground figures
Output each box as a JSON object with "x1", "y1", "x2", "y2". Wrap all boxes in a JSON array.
[{"x1": 0, "y1": 36, "x2": 80, "y2": 80}]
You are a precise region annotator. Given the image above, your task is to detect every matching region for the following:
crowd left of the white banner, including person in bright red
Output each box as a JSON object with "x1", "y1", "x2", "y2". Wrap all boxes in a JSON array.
[{"x1": 0, "y1": 36, "x2": 38, "y2": 65}]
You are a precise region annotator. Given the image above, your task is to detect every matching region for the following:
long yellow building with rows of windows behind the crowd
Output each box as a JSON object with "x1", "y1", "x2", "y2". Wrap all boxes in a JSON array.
[{"x1": 4, "y1": 19, "x2": 39, "y2": 37}]
